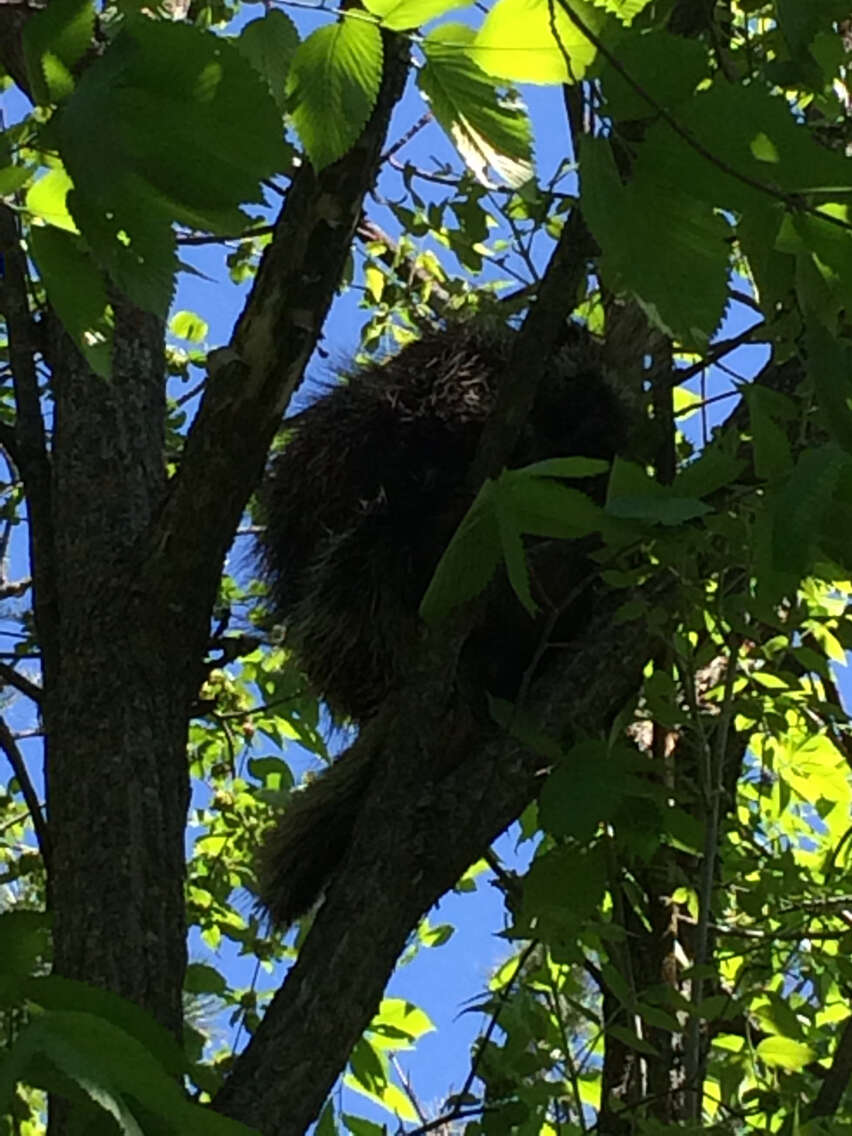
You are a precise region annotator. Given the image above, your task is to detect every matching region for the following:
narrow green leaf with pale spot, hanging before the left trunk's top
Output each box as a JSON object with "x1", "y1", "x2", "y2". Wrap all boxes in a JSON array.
[{"x1": 30, "y1": 226, "x2": 112, "y2": 377}]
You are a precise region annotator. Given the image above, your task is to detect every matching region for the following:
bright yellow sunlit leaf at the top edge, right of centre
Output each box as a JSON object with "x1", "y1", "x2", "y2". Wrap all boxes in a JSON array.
[{"x1": 470, "y1": 0, "x2": 605, "y2": 83}]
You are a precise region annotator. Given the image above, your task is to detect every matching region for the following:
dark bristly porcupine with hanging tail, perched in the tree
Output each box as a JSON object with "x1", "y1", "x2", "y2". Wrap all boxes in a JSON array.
[{"x1": 258, "y1": 320, "x2": 624, "y2": 925}]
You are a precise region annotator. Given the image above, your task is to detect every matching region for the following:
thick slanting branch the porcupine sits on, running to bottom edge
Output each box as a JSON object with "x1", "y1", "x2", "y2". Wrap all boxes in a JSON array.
[{"x1": 216, "y1": 581, "x2": 649, "y2": 1136}]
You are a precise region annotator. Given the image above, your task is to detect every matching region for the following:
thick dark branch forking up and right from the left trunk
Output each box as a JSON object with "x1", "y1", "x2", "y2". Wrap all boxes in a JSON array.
[{"x1": 150, "y1": 35, "x2": 409, "y2": 636}]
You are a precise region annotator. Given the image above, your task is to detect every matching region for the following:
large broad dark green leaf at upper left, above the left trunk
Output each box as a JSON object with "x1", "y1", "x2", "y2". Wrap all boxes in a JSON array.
[{"x1": 56, "y1": 17, "x2": 285, "y2": 316}]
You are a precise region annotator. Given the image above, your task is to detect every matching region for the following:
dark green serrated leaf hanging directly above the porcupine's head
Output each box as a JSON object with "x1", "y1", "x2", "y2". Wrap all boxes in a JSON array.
[{"x1": 580, "y1": 137, "x2": 730, "y2": 349}]
